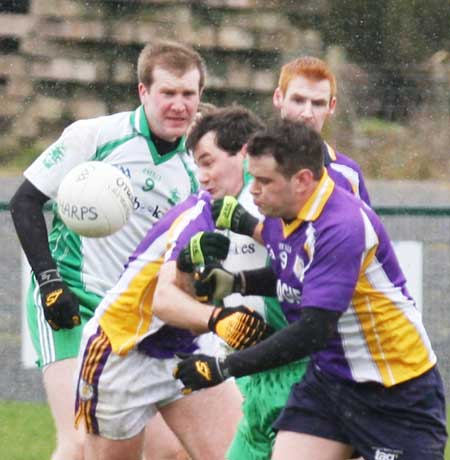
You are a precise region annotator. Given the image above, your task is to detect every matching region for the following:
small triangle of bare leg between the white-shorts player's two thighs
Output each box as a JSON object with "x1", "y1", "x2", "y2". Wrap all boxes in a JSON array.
[{"x1": 144, "y1": 413, "x2": 189, "y2": 460}]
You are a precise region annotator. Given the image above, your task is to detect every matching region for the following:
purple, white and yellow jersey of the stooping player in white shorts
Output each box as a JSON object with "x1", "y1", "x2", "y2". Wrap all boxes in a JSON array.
[{"x1": 95, "y1": 191, "x2": 214, "y2": 358}]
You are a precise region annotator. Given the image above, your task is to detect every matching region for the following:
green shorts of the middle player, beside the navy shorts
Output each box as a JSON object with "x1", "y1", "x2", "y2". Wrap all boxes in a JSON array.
[{"x1": 226, "y1": 359, "x2": 309, "y2": 460}]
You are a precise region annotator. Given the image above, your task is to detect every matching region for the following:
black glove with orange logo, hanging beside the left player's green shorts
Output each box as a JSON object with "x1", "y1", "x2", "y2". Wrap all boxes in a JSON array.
[{"x1": 36, "y1": 269, "x2": 81, "y2": 331}]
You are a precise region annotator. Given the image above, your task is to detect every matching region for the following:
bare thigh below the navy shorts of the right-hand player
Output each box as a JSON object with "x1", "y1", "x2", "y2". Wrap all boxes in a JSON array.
[{"x1": 272, "y1": 431, "x2": 353, "y2": 460}]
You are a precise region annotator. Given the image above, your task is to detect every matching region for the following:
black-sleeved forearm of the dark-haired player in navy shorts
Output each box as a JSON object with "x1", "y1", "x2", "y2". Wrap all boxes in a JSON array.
[{"x1": 224, "y1": 308, "x2": 340, "y2": 377}]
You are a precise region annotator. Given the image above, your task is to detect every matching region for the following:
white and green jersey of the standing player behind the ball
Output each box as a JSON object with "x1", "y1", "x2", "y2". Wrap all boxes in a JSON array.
[{"x1": 24, "y1": 106, "x2": 197, "y2": 309}]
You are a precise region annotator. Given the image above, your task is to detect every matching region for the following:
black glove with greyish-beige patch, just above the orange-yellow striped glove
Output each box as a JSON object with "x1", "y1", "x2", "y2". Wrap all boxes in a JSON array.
[{"x1": 194, "y1": 264, "x2": 244, "y2": 303}]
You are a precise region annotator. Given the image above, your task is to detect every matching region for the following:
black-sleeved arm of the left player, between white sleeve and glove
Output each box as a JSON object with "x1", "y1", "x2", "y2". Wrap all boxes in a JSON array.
[{"x1": 10, "y1": 180, "x2": 56, "y2": 273}]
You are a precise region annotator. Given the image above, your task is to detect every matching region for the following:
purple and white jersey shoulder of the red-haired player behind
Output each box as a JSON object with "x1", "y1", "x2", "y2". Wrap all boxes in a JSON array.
[{"x1": 323, "y1": 142, "x2": 370, "y2": 206}]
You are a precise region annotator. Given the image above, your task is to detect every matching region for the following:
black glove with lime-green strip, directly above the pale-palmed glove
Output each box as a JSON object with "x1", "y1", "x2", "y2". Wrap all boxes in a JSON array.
[{"x1": 177, "y1": 232, "x2": 230, "y2": 273}]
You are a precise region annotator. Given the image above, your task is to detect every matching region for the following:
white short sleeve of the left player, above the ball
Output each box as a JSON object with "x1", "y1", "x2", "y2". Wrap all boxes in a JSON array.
[{"x1": 24, "y1": 117, "x2": 102, "y2": 198}]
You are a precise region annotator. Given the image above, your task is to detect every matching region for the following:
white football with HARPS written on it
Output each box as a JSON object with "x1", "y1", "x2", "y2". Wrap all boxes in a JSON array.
[{"x1": 56, "y1": 161, "x2": 134, "y2": 238}]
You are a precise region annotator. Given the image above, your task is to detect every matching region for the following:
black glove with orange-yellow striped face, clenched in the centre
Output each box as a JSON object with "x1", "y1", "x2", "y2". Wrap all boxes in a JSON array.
[{"x1": 208, "y1": 305, "x2": 270, "y2": 350}]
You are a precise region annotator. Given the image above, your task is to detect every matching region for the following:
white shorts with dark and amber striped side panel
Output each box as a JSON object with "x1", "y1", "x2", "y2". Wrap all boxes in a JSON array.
[{"x1": 75, "y1": 318, "x2": 187, "y2": 439}]
